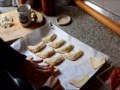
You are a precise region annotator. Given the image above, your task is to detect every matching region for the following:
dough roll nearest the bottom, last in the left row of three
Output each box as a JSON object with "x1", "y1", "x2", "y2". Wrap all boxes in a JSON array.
[{"x1": 43, "y1": 54, "x2": 64, "y2": 66}]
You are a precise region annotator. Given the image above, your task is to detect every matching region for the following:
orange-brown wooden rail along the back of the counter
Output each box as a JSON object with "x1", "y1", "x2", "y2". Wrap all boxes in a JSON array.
[{"x1": 75, "y1": 0, "x2": 120, "y2": 36}]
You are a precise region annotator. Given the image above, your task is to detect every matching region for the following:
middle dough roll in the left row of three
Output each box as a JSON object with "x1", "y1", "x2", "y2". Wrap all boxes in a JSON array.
[{"x1": 36, "y1": 49, "x2": 55, "y2": 58}]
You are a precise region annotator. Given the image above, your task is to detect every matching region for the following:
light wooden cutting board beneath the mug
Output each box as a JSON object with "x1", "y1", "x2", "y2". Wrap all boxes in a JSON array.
[{"x1": 0, "y1": 10, "x2": 43, "y2": 42}]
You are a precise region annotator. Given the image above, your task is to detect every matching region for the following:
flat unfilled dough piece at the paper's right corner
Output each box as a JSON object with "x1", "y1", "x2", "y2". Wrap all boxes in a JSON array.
[{"x1": 89, "y1": 57, "x2": 105, "y2": 69}]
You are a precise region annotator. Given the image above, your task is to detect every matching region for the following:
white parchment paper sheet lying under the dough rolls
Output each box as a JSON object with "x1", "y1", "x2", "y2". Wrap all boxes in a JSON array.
[{"x1": 11, "y1": 23, "x2": 109, "y2": 90}]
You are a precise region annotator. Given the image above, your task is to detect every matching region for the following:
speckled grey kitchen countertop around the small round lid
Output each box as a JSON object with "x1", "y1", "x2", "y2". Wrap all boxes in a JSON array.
[{"x1": 0, "y1": 2, "x2": 120, "y2": 90}]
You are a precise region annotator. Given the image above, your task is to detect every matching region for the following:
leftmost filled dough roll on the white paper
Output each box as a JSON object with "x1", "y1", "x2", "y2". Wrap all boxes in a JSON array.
[{"x1": 27, "y1": 42, "x2": 46, "y2": 53}]
